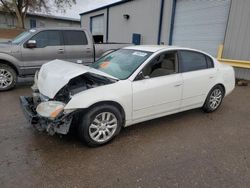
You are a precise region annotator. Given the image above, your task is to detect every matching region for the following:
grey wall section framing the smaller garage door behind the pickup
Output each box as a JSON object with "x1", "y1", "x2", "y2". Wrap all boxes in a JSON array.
[{"x1": 81, "y1": 9, "x2": 107, "y2": 41}]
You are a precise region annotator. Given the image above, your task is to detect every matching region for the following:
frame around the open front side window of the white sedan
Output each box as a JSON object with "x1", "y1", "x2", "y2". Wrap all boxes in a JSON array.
[{"x1": 133, "y1": 50, "x2": 181, "y2": 82}]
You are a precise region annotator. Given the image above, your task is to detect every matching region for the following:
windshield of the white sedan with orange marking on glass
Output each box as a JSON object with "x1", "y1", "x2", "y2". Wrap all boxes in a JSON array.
[{"x1": 91, "y1": 49, "x2": 152, "y2": 80}]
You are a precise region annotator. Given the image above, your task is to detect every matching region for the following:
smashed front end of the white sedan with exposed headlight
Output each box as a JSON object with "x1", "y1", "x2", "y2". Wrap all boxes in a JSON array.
[{"x1": 20, "y1": 74, "x2": 75, "y2": 135}]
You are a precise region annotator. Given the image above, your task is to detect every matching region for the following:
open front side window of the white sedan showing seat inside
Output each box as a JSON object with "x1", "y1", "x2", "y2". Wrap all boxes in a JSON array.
[{"x1": 142, "y1": 51, "x2": 178, "y2": 78}]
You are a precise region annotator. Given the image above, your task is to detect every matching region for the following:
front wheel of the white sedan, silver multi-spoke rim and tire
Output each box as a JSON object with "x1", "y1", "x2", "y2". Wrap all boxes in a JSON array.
[{"x1": 78, "y1": 104, "x2": 122, "y2": 147}]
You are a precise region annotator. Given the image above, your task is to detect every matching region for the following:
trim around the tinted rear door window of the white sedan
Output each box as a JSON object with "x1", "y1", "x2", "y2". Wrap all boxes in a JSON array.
[{"x1": 177, "y1": 49, "x2": 214, "y2": 73}]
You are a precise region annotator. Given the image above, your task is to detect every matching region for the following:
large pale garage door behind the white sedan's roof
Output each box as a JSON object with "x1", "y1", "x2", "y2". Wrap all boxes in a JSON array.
[{"x1": 172, "y1": 0, "x2": 230, "y2": 56}]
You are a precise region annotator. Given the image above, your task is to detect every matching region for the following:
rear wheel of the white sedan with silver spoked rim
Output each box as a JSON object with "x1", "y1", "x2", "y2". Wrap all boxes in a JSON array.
[{"x1": 202, "y1": 85, "x2": 225, "y2": 113}]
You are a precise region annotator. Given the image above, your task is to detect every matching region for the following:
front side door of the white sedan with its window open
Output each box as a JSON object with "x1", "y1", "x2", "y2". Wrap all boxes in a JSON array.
[{"x1": 132, "y1": 51, "x2": 182, "y2": 122}]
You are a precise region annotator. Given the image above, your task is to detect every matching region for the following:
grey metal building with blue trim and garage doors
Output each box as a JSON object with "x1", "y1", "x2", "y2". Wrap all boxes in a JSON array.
[{"x1": 81, "y1": 0, "x2": 250, "y2": 79}]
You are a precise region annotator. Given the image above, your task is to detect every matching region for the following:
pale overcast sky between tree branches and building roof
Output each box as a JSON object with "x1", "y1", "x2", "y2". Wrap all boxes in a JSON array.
[{"x1": 56, "y1": 0, "x2": 120, "y2": 19}]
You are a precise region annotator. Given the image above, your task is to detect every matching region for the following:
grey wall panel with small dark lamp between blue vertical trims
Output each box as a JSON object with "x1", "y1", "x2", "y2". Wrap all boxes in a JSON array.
[{"x1": 109, "y1": 0, "x2": 161, "y2": 44}]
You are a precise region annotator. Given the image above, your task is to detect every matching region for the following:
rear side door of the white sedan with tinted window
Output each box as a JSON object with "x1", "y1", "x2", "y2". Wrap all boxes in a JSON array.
[{"x1": 178, "y1": 50, "x2": 216, "y2": 110}]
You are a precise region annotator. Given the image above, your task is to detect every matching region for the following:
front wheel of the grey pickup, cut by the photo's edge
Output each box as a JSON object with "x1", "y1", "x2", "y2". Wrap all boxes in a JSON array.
[{"x1": 0, "y1": 64, "x2": 17, "y2": 91}]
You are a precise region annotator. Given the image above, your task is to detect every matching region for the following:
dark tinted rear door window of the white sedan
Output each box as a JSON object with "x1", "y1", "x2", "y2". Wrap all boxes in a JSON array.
[{"x1": 179, "y1": 50, "x2": 208, "y2": 72}]
